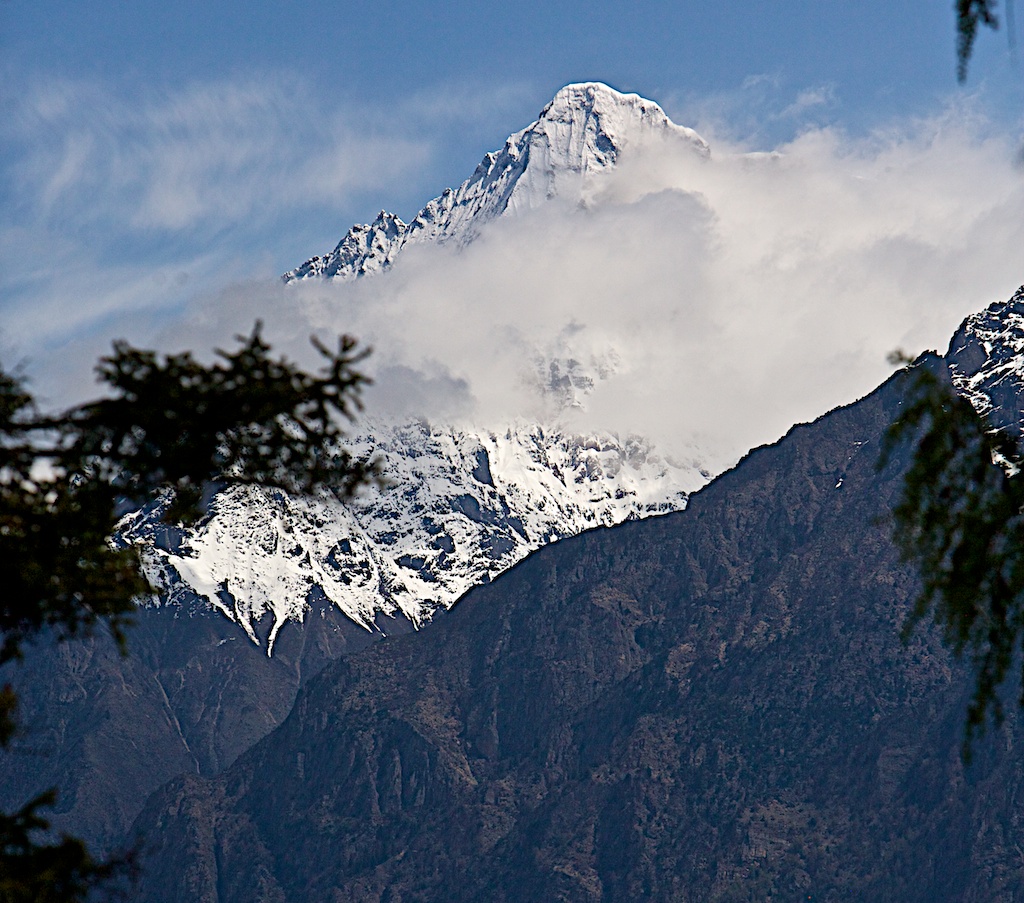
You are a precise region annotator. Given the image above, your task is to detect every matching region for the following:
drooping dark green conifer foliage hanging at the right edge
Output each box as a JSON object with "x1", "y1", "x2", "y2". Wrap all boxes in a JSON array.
[{"x1": 879, "y1": 356, "x2": 1024, "y2": 759}]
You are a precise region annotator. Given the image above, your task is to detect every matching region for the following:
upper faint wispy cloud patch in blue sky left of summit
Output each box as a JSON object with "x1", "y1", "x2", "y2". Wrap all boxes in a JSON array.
[{"x1": 5, "y1": 76, "x2": 430, "y2": 231}]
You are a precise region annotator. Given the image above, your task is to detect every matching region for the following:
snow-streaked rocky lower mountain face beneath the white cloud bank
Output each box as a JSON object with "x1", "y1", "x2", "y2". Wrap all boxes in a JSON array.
[{"x1": 122, "y1": 422, "x2": 709, "y2": 654}]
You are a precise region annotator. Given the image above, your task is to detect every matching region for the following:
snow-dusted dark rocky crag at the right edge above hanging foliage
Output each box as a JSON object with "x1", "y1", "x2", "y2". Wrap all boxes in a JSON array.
[{"x1": 946, "y1": 286, "x2": 1024, "y2": 435}]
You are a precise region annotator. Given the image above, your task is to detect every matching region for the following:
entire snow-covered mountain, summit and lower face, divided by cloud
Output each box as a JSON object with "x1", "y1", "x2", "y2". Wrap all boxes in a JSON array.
[{"x1": 121, "y1": 83, "x2": 711, "y2": 653}]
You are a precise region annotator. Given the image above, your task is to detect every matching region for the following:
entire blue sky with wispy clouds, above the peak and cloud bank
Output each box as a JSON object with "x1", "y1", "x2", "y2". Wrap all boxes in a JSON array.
[{"x1": 0, "y1": 0, "x2": 1024, "y2": 444}]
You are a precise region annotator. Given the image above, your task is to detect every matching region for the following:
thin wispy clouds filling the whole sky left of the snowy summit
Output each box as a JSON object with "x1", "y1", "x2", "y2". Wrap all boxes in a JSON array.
[{"x1": 0, "y1": 67, "x2": 528, "y2": 382}]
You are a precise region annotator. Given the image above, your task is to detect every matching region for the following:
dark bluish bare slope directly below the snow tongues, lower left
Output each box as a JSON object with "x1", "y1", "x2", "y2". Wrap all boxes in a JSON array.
[{"x1": 0, "y1": 603, "x2": 411, "y2": 850}]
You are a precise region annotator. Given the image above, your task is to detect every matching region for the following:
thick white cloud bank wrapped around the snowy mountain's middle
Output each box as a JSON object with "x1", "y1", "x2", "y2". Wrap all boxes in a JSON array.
[{"x1": 176, "y1": 101, "x2": 1024, "y2": 466}]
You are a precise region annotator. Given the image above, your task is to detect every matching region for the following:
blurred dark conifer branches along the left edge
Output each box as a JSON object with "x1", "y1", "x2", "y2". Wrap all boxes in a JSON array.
[{"x1": 0, "y1": 323, "x2": 377, "y2": 903}]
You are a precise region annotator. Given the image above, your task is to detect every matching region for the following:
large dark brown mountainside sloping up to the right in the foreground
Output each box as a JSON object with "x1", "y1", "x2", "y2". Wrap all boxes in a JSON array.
[{"x1": 128, "y1": 360, "x2": 1024, "y2": 903}]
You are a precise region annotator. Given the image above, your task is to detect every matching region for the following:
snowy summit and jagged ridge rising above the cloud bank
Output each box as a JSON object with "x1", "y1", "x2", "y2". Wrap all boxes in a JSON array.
[{"x1": 283, "y1": 82, "x2": 711, "y2": 282}]
